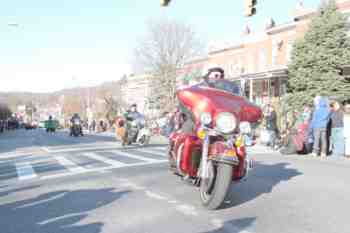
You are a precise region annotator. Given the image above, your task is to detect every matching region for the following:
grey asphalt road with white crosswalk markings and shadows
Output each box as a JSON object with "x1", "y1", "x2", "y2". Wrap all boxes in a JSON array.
[{"x1": 0, "y1": 130, "x2": 350, "y2": 233}]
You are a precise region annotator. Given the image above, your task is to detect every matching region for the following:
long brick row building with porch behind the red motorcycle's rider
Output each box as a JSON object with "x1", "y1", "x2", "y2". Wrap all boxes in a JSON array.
[{"x1": 178, "y1": 0, "x2": 350, "y2": 105}]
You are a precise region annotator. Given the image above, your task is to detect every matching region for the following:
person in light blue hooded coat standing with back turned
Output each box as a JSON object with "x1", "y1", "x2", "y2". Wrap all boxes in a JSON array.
[{"x1": 311, "y1": 96, "x2": 331, "y2": 157}]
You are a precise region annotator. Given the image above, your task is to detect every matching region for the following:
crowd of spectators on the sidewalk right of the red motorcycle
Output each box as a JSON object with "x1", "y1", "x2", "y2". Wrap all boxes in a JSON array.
[{"x1": 261, "y1": 96, "x2": 350, "y2": 157}]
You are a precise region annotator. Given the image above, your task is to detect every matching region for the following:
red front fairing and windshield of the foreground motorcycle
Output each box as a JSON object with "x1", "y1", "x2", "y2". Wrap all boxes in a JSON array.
[{"x1": 177, "y1": 80, "x2": 262, "y2": 123}]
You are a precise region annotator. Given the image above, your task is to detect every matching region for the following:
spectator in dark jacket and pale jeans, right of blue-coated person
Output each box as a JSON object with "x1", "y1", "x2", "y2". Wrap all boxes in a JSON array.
[{"x1": 331, "y1": 101, "x2": 345, "y2": 156}]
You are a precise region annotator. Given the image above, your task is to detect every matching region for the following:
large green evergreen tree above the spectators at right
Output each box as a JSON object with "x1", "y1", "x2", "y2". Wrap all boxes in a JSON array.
[{"x1": 286, "y1": 0, "x2": 350, "y2": 110}]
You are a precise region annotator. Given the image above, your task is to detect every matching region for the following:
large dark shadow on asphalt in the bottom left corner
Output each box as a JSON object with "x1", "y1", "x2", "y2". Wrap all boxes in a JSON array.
[{"x1": 0, "y1": 188, "x2": 130, "y2": 233}]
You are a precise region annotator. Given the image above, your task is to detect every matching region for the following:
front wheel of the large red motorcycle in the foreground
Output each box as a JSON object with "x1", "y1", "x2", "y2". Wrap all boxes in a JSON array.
[{"x1": 200, "y1": 161, "x2": 233, "y2": 210}]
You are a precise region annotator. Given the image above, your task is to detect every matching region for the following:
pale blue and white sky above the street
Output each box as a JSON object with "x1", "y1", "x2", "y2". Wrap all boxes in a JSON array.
[{"x1": 0, "y1": 0, "x2": 319, "y2": 92}]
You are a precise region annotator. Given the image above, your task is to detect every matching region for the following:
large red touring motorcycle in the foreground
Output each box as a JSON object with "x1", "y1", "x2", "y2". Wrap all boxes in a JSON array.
[{"x1": 168, "y1": 80, "x2": 262, "y2": 210}]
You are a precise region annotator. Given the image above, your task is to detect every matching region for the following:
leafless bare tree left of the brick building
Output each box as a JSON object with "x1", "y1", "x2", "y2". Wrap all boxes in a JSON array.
[{"x1": 134, "y1": 20, "x2": 203, "y2": 112}]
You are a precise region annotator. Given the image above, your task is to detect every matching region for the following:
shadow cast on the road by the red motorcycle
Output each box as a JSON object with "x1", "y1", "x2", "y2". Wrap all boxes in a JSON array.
[{"x1": 223, "y1": 163, "x2": 302, "y2": 209}]
